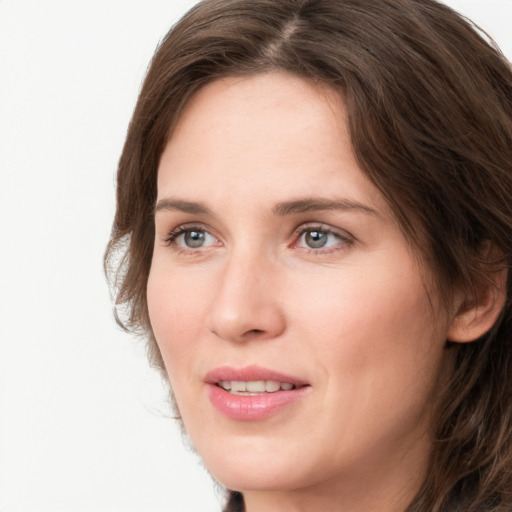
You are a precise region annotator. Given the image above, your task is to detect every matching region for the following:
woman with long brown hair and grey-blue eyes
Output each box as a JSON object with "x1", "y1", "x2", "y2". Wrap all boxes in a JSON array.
[{"x1": 106, "y1": 0, "x2": 512, "y2": 512}]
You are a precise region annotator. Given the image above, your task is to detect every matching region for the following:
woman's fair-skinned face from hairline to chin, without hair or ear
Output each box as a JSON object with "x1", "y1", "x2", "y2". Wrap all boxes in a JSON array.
[{"x1": 148, "y1": 73, "x2": 456, "y2": 506}]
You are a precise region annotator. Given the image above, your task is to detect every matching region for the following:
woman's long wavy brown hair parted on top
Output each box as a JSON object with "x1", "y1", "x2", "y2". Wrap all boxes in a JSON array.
[{"x1": 105, "y1": 0, "x2": 512, "y2": 512}]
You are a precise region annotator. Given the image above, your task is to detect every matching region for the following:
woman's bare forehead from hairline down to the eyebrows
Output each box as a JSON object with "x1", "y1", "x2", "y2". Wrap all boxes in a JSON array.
[{"x1": 158, "y1": 72, "x2": 382, "y2": 212}]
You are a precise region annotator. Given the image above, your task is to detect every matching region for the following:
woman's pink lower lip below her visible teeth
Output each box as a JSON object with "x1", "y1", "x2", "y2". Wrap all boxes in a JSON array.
[{"x1": 208, "y1": 384, "x2": 310, "y2": 421}]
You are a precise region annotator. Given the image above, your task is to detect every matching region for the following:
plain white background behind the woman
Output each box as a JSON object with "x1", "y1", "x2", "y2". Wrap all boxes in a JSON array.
[{"x1": 0, "y1": 0, "x2": 512, "y2": 512}]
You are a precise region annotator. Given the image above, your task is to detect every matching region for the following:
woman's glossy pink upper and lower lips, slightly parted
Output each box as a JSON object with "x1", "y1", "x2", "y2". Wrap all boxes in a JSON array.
[{"x1": 204, "y1": 366, "x2": 311, "y2": 421}]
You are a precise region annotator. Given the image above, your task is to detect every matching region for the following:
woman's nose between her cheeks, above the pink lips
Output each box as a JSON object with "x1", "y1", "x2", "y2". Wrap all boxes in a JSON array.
[{"x1": 207, "y1": 250, "x2": 286, "y2": 342}]
